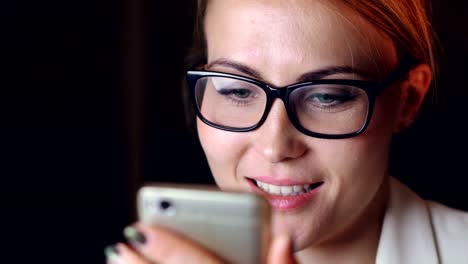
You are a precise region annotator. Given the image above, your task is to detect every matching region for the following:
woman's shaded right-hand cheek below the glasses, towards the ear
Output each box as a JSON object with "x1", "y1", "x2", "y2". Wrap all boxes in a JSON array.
[{"x1": 313, "y1": 86, "x2": 401, "y2": 181}]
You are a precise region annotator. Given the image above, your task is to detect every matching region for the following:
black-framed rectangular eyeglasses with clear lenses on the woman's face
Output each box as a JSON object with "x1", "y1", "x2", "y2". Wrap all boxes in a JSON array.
[{"x1": 186, "y1": 67, "x2": 406, "y2": 139}]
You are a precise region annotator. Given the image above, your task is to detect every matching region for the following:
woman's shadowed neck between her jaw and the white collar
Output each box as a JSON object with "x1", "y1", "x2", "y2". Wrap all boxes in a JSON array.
[{"x1": 296, "y1": 177, "x2": 390, "y2": 264}]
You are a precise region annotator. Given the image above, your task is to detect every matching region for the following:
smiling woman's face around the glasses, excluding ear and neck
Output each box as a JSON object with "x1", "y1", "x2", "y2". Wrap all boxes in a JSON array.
[{"x1": 197, "y1": 0, "x2": 400, "y2": 249}]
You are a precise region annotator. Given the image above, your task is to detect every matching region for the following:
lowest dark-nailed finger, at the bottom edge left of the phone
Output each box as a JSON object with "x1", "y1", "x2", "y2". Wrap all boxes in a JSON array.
[{"x1": 104, "y1": 243, "x2": 150, "y2": 264}]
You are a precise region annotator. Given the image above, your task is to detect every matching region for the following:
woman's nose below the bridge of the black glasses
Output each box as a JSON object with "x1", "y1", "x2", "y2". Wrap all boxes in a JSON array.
[{"x1": 253, "y1": 99, "x2": 307, "y2": 163}]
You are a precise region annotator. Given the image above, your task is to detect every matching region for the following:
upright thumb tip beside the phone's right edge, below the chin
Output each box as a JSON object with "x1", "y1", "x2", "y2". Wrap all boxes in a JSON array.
[{"x1": 267, "y1": 234, "x2": 297, "y2": 264}]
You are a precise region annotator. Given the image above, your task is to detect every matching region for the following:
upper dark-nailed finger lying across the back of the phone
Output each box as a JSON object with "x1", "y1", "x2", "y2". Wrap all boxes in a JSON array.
[{"x1": 124, "y1": 224, "x2": 222, "y2": 264}]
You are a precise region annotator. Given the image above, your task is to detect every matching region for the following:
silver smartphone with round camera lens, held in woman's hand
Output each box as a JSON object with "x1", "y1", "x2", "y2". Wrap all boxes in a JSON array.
[{"x1": 137, "y1": 184, "x2": 271, "y2": 264}]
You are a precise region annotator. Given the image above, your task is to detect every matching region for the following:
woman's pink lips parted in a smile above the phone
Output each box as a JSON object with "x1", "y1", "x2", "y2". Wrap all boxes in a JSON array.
[{"x1": 247, "y1": 177, "x2": 323, "y2": 211}]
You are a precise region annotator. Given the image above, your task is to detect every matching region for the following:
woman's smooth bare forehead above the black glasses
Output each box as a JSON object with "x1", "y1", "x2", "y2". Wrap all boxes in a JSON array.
[{"x1": 205, "y1": 0, "x2": 397, "y2": 82}]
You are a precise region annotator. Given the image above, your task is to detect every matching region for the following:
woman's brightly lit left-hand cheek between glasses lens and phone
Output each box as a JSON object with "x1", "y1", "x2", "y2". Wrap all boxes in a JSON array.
[{"x1": 197, "y1": 119, "x2": 248, "y2": 190}]
